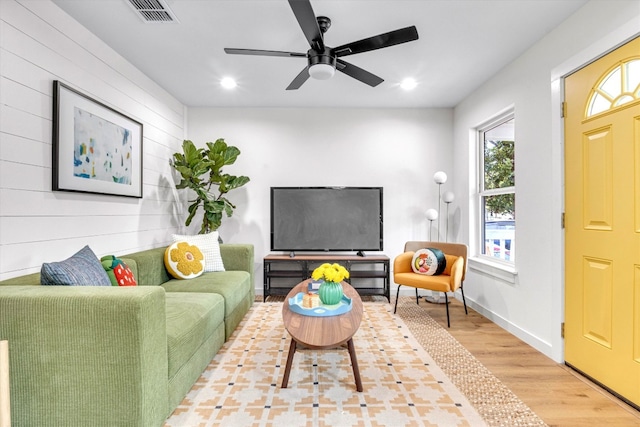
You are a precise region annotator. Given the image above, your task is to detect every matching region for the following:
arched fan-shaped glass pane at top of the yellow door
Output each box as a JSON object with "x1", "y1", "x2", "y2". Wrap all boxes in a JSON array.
[{"x1": 586, "y1": 58, "x2": 640, "y2": 117}]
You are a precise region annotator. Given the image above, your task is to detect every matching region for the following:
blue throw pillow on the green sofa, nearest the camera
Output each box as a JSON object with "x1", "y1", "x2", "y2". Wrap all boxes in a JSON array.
[{"x1": 40, "y1": 246, "x2": 111, "y2": 286}]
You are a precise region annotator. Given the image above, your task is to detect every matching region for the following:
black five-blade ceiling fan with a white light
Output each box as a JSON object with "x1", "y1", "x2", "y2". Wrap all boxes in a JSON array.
[{"x1": 224, "y1": 0, "x2": 418, "y2": 90}]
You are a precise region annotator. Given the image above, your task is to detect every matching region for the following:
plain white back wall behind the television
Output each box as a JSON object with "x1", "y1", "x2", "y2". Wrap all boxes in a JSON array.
[{"x1": 188, "y1": 108, "x2": 455, "y2": 293}]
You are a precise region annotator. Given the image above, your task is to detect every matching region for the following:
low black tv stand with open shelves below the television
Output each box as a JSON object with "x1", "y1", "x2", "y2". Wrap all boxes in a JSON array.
[{"x1": 263, "y1": 252, "x2": 391, "y2": 302}]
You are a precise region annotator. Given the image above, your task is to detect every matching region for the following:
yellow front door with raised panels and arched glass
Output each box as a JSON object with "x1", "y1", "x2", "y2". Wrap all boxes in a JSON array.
[{"x1": 565, "y1": 38, "x2": 640, "y2": 405}]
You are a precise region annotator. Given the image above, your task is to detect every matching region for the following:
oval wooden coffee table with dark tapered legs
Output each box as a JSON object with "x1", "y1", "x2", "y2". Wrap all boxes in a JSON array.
[{"x1": 282, "y1": 279, "x2": 362, "y2": 391}]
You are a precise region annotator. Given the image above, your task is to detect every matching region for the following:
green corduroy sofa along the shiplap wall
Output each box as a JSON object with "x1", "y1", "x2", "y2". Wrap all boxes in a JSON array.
[{"x1": 0, "y1": 244, "x2": 255, "y2": 427}]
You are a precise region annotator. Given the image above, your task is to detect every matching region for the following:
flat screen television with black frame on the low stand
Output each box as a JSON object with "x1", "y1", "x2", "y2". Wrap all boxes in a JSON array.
[{"x1": 271, "y1": 187, "x2": 383, "y2": 254}]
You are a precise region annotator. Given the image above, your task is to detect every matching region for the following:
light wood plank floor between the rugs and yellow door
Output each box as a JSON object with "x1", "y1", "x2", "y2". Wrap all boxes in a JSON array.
[{"x1": 420, "y1": 299, "x2": 640, "y2": 427}]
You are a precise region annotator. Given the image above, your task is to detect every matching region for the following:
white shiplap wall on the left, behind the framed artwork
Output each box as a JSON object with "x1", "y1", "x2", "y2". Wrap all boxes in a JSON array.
[{"x1": 0, "y1": 0, "x2": 185, "y2": 279}]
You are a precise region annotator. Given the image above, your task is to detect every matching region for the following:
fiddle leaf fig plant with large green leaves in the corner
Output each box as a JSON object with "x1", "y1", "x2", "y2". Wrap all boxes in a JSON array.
[{"x1": 169, "y1": 138, "x2": 249, "y2": 234}]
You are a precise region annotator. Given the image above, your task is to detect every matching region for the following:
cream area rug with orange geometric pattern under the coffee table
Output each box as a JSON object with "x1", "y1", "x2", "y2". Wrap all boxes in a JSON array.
[{"x1": 165, "y1": 302, "x2": 486, "y2": 427}]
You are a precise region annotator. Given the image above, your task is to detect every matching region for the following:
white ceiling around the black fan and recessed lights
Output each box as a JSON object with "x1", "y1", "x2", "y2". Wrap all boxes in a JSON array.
[{"x1": 52, "y1": 0, "x2": 587, "y2": 108}]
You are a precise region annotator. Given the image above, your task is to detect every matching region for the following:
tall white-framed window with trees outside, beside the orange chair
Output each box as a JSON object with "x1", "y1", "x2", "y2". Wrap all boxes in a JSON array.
[{"x1": 478, "y1": 112, "x2": 516, "y2": 262}]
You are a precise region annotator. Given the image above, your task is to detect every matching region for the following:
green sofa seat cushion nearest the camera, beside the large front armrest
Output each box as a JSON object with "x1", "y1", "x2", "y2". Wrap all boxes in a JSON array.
[{"x1": 166, "y1": 292, "x2": 224, "y2": 378}]
